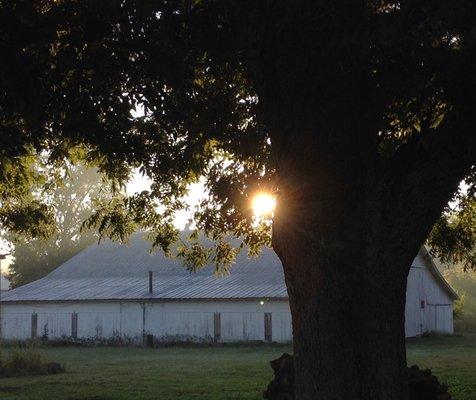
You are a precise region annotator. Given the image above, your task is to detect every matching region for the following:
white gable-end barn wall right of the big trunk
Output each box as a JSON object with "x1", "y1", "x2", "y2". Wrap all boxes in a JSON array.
[{"x1": 405, "y1": 254, "x2": 453, "y2": 337}]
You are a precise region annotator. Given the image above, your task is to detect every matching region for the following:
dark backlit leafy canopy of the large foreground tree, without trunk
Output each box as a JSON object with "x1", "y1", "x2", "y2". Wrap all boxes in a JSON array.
[{"x1": 0, "y1": 0, "x2": 476, "y2": 266}]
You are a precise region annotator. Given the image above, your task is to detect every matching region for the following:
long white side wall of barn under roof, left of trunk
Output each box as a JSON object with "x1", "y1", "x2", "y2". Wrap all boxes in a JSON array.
[{"x1": 1, "y1": 300, "x2": 292, "y2": 342}]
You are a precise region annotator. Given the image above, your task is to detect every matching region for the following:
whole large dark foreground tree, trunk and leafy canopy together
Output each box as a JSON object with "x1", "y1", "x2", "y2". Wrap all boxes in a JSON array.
[{"x1": 0, "y1": 0, "x2": 476, "y2": 400}]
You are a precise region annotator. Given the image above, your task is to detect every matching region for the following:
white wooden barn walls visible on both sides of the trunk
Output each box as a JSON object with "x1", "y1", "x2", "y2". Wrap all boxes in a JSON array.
[{"x1": 0, "y1": 254, "x2": 453, "y2": 342}]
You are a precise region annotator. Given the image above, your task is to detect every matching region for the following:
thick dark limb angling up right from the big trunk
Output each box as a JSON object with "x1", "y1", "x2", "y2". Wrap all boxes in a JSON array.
[{"x1": 384, "y1": 113, "x2": 476, "y2": 260}]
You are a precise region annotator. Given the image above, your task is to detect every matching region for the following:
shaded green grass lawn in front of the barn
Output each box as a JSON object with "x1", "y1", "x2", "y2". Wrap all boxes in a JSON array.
[{"x1": 0, "y1": 335, "x2": 476, "y2": 400}]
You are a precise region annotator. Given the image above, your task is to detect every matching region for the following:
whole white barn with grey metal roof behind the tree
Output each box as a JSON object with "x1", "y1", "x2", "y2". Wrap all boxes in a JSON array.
[{"x1": 0, "y1": 234, "x2": 457, "y2": 343}]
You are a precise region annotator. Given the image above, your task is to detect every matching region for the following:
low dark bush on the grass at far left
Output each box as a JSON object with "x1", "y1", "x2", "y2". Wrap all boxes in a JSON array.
[{"x1": 0, "y1": 348, "x2": 64, "y2": 377}]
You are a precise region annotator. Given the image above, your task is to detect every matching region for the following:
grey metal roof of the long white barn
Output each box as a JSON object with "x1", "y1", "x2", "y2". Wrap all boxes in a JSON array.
[{"x1": 2, "y1": 234, "x2": 287, "y2": 302}]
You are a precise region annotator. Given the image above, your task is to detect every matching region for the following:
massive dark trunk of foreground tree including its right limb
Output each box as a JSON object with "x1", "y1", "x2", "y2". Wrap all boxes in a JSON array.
[{"x1": 250, "y1": 1, "x2": 474, "y2": 400}]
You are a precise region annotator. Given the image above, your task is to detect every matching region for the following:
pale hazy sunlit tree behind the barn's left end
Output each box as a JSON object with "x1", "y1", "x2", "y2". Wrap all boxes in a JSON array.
[{"x1": 7, "y1": 165, "x2": 112, "y2": 287}]
